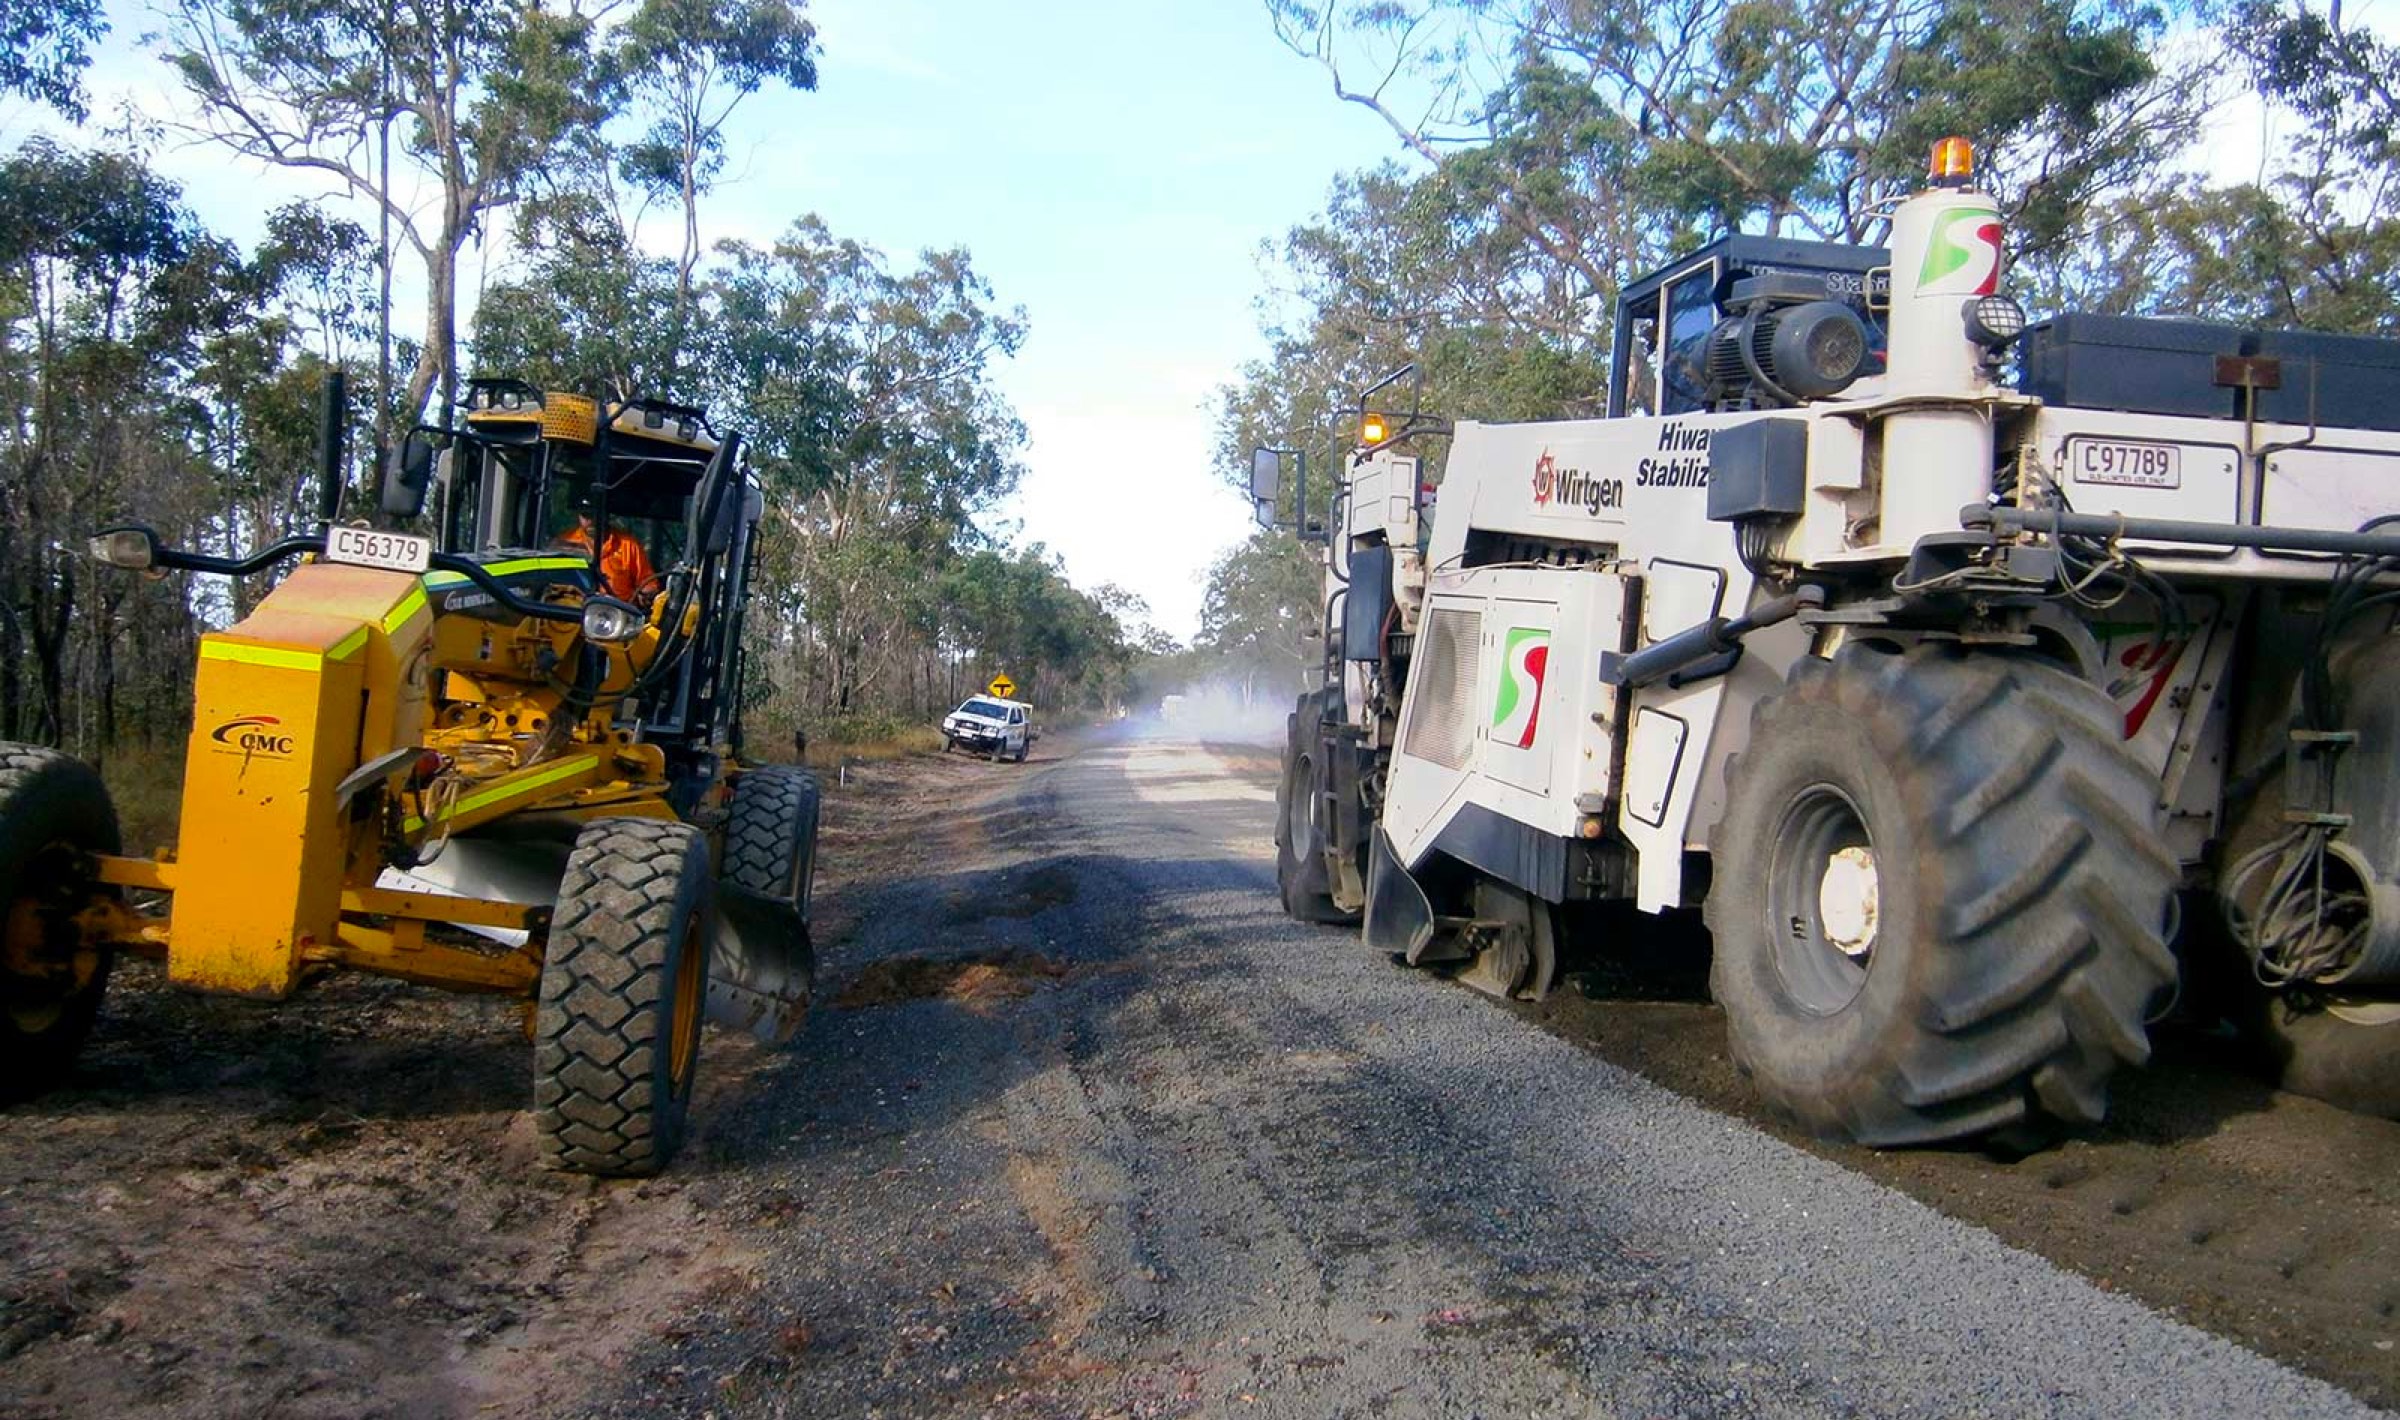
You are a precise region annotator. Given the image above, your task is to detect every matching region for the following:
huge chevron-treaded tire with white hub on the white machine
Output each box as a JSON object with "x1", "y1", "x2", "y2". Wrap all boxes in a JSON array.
[{"x1": 1706, "y1": 645, "x2": 2177, "y2": 1147}]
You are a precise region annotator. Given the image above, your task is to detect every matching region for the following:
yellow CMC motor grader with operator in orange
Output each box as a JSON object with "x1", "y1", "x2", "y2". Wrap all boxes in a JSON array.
[{"x1": 0, "y1": 379, "x2": 818, "y2": 1175}]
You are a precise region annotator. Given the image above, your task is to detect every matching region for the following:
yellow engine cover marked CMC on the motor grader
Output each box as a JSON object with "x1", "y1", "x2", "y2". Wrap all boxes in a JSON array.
[{"x1": 168, "y1": 564, "x2": 432, "y2": 998}]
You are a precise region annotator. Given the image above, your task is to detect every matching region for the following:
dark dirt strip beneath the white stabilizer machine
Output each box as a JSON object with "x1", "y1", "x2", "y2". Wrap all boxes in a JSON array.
[{"x1": 1210, "y1": 746, "x2": 2400, "y2": 1408}]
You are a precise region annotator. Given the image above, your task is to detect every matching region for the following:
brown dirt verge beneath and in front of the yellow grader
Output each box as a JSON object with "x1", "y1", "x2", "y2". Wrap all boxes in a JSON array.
[{"x1": 0, "y1": 756, "x2": 1020, "y2": 1418}]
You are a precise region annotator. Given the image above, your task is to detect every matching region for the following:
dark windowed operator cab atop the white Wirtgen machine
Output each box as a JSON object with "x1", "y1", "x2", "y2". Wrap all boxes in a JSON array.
[{"x1": 1608, "y1": 233, "x2": 1891, "y2": 420}]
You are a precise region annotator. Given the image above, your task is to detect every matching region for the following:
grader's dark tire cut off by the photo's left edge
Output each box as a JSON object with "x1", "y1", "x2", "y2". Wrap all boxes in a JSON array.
[{"x1": 0, "y1": 744, "x2": 120, "y2": 1101}]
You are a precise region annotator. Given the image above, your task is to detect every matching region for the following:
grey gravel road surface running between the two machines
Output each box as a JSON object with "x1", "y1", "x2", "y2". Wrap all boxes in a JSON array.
[{"x1": 607, "y1": 739, "x2": 2366, "y2": 1418}]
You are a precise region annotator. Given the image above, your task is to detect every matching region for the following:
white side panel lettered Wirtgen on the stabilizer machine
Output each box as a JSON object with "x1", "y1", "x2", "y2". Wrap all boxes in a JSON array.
[{"x1": 1385, "y1": 415, "x2": 1807, "y2": 909}]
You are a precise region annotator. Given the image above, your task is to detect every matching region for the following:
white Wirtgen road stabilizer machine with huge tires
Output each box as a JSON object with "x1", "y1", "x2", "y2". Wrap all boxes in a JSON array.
[{"x1": 1253, "y1": 139, "x2": 2400, "y2": 1147}]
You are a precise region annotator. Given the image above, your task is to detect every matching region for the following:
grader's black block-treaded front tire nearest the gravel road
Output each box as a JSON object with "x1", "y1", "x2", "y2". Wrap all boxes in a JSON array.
[{"x1": 533, "y1": 818, "x2": 715, "y2": 1175}]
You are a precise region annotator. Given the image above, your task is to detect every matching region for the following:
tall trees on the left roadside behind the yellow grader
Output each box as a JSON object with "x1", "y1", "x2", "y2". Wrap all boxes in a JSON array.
[{"x1": 0, "y1": 0, "x2": 1147, "y2": 786}]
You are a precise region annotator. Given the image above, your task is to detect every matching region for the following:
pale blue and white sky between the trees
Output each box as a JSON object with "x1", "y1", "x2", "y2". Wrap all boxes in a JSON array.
[{"x1": 14, "y1": 0, "x2": 1394, "y2": 638}]
